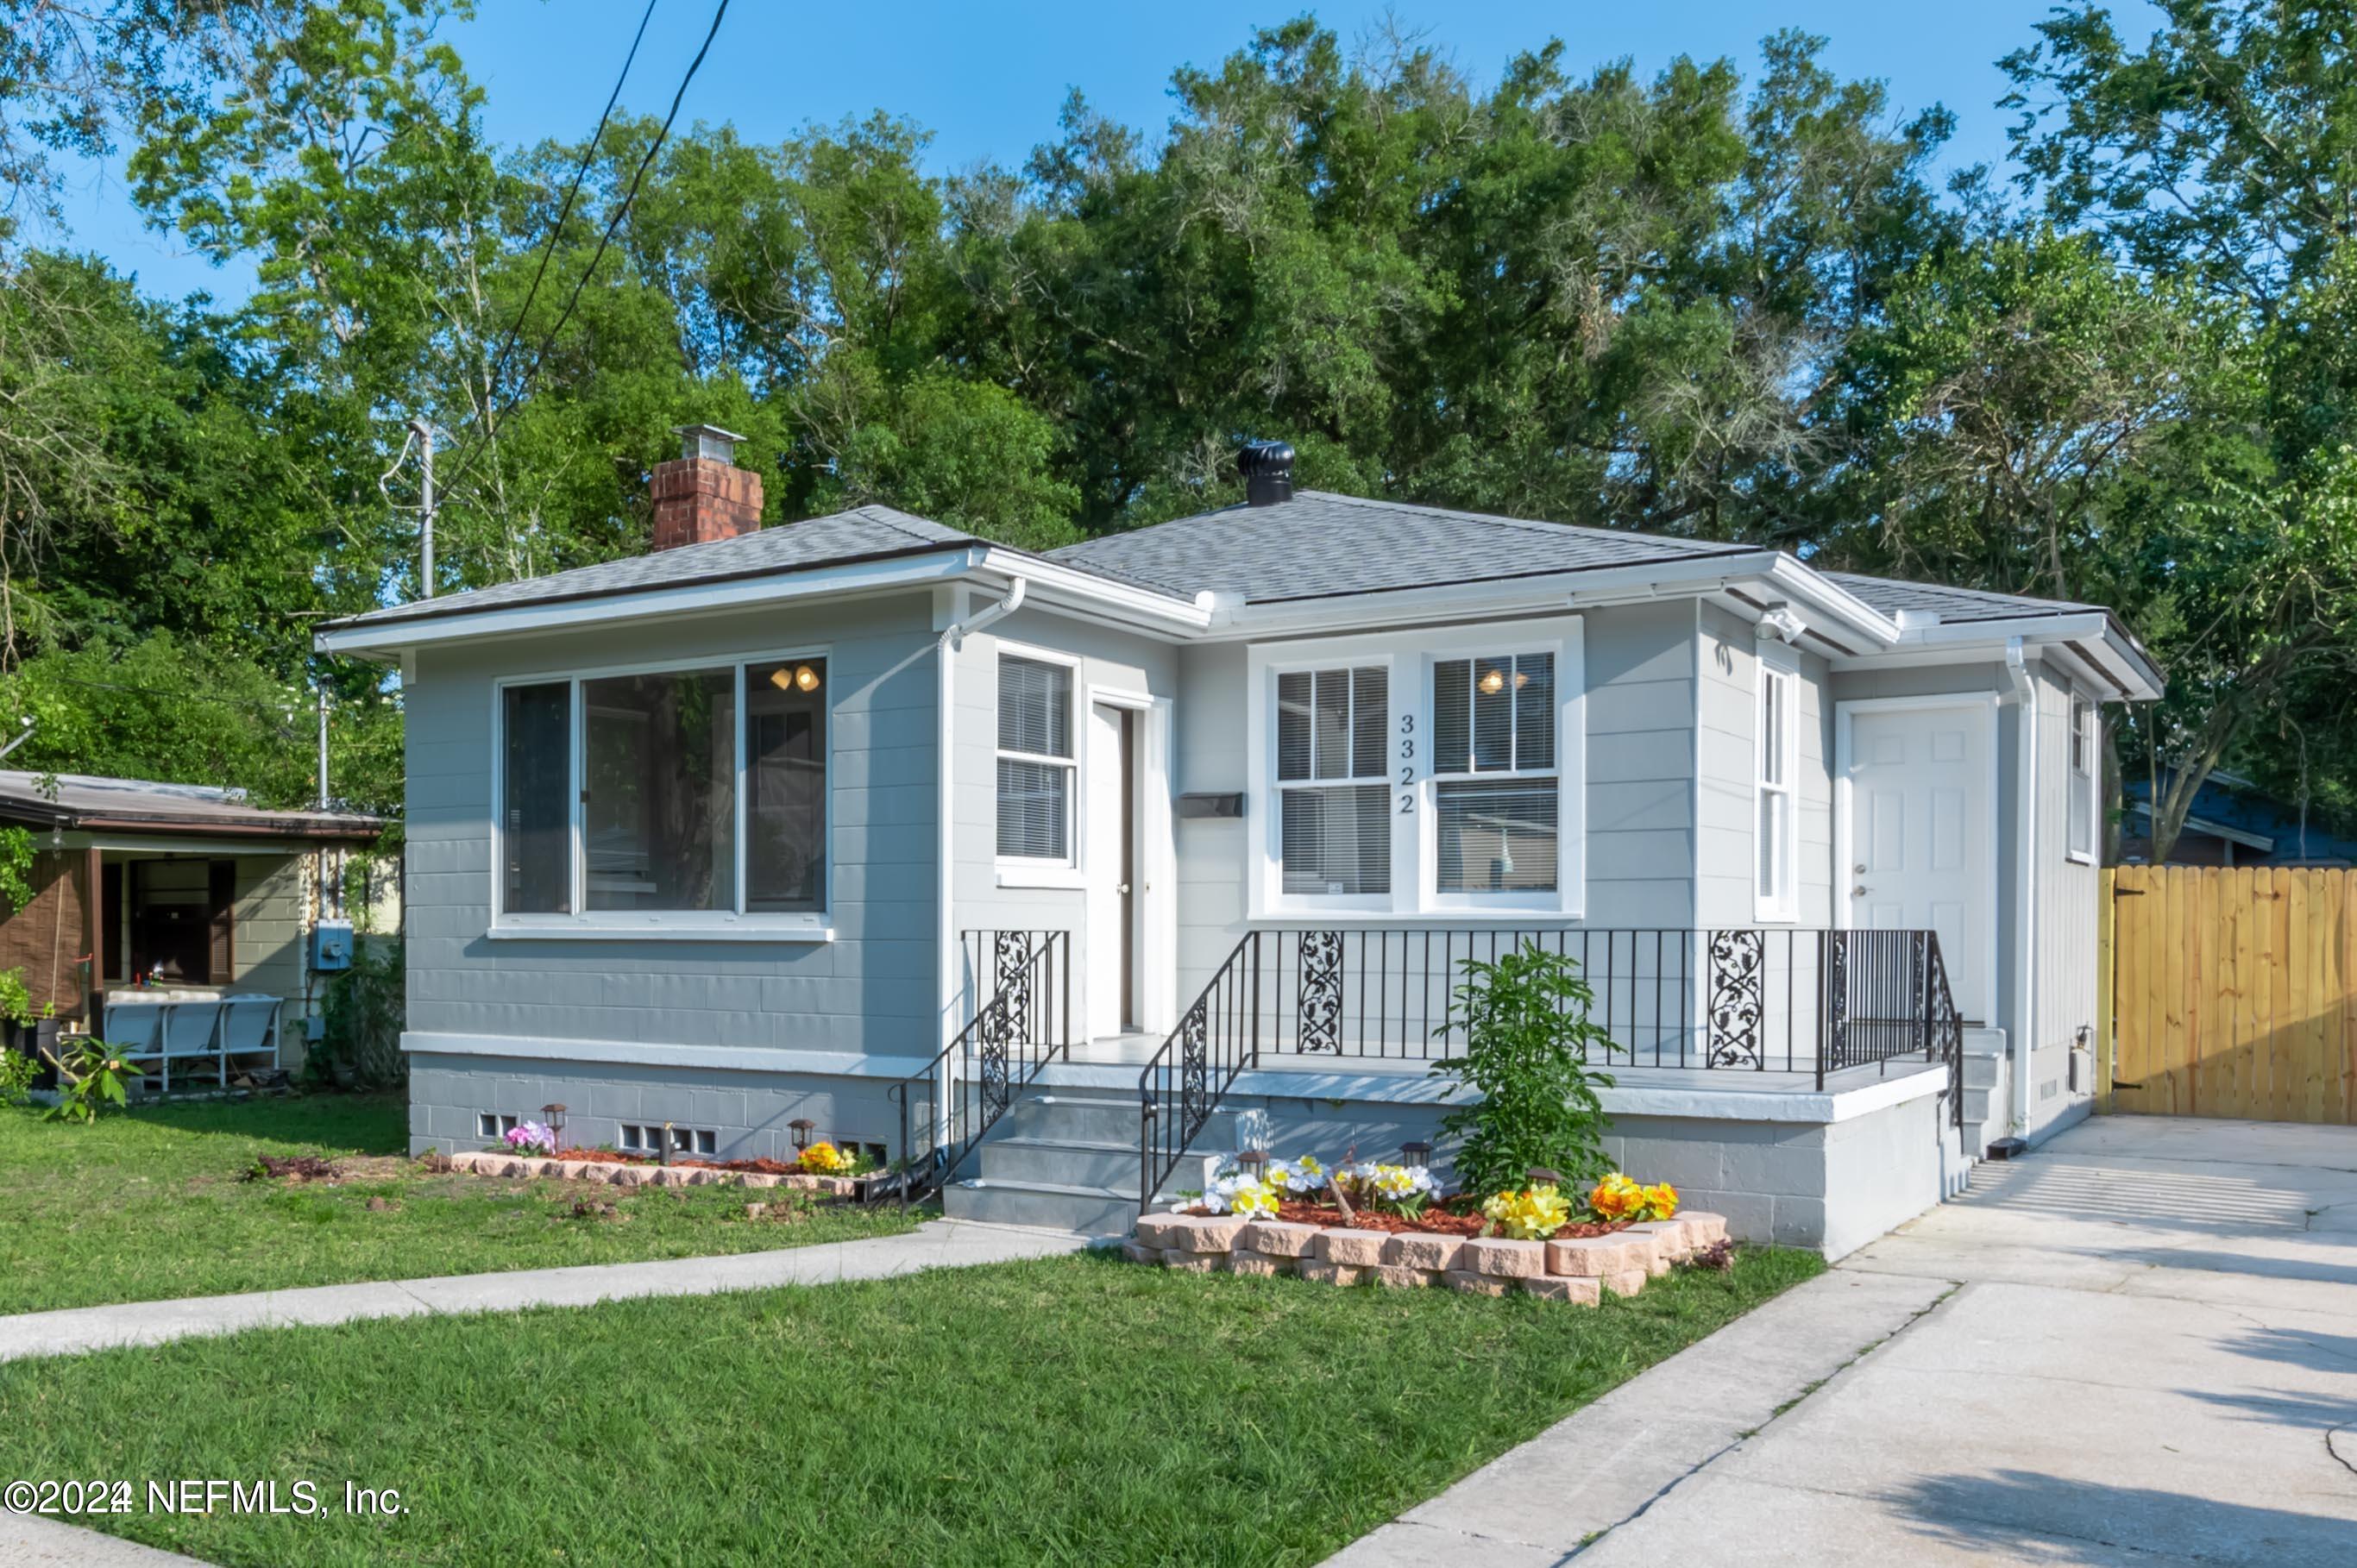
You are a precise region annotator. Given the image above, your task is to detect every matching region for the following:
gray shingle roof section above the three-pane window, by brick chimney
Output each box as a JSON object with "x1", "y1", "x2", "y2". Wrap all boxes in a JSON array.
[{"x1": 330, "y1": 507, "x2": 981, "y2": 624}]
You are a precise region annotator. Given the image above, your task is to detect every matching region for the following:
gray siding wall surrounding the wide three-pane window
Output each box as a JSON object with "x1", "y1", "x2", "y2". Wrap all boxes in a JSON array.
[{"x1": 403, "y1": 594, "x2": 936, "y2": 1061}]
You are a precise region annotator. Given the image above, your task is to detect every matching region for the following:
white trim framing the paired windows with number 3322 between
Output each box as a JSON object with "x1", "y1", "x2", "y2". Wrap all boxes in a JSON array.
[{"x1": 1244, "y1": 616, "x2": 1588, "y2": 925}]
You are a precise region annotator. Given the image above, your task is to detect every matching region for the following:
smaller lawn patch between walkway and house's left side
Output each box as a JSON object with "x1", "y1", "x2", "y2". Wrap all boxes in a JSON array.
[{"x1": 0, "y1": 1094, "x2": 910, "y2": 1314}]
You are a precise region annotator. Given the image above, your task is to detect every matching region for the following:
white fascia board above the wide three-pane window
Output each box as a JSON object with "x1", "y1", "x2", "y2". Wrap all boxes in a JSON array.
[{"x1": 311, "y1": 547, "x2": 985, "y2": 655}]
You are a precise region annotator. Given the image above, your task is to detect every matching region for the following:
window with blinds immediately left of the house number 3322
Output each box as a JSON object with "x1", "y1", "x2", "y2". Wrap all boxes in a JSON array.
[{"x1": 1278, "y1": 665, "x2": 1391, "y2": 899}]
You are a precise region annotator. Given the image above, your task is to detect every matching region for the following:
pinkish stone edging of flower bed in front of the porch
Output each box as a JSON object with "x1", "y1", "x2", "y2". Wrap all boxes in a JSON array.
[{"x1": 1122, "y1": 1214, "x2": 1728, "y2": 1307}]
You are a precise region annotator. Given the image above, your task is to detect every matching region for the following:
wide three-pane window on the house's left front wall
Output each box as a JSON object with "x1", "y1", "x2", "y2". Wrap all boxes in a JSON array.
[{"x1": 493, "y1": 655, "x2": 827, "y2": 931}]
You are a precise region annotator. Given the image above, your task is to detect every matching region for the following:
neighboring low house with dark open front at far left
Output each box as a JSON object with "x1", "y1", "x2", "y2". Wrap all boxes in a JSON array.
[{"x1": 0, "y1": 771, "x2": 384, "y2": 1089}]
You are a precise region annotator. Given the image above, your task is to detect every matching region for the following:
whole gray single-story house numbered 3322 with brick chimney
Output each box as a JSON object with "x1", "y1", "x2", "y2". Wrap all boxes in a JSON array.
[{"x1": 318, "y1": 430, "x2": 2159, "y2": 1252}]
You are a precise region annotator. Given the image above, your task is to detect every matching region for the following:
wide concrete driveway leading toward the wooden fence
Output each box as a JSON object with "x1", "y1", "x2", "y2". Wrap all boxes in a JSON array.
[{"x1": 1334, "y1": 1118, "x2": 2357, "y2": 1568}]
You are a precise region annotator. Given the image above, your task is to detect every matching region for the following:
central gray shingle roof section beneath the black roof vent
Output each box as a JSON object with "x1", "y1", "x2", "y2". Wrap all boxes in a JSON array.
[{"x1": 1049, "y1": 491, "x2": 1754, "y2": 604}]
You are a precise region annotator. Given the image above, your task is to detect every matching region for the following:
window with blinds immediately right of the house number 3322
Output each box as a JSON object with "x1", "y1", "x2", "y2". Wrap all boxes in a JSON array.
[{"x1": 1433, "y1": 653, "x2": 1562, "y2": 894}]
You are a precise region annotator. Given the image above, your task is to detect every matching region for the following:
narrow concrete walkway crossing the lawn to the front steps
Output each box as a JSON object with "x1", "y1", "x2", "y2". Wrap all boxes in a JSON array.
[{"x1": 0, "y1": 1219, "x2": 1089, "y2": 1360}]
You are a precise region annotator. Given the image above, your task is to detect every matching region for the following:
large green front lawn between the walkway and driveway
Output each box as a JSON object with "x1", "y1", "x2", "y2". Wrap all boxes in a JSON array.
[{"x1": 0, "y1": 1252, "x2": 1825, "y2": 1568}]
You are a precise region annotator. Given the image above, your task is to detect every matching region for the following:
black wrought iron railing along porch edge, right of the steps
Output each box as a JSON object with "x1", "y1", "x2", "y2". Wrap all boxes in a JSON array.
[{"x1": 1139, "y1": 926, "x2": 1964, "y2": 1201}]
